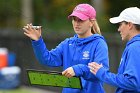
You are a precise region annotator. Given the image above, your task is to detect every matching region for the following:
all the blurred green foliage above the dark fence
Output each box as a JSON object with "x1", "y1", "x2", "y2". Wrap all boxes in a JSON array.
[{"x1": 0, "y1": 0, "x2": 140, "y2": 32}]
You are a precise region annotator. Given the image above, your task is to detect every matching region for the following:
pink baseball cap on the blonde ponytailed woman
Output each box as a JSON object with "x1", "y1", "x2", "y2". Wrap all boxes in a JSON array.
[{"x1": 68, "y1": 4, "x2": 96, "y2": 20}]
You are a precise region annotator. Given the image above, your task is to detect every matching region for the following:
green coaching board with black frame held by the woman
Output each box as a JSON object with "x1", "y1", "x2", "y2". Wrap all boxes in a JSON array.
[{"x1": 27, "y1": 69, "x2": 82, "y2": 89}]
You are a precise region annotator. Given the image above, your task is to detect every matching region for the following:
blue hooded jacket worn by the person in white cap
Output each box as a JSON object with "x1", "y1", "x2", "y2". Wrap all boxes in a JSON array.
[{"x1": 96, "y1": 35, "x2": 140, "y2": 93}]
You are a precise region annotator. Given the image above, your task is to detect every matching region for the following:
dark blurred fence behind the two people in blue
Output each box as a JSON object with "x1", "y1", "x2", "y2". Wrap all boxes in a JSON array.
[{"x1": 0, "y1": 30, "x2": 124, "y2": 93}]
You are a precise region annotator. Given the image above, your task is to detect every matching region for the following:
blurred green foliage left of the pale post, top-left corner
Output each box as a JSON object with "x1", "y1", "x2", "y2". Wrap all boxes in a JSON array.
[{"x1": 0, "y1": 0, "x2": 21, "y2": 28}]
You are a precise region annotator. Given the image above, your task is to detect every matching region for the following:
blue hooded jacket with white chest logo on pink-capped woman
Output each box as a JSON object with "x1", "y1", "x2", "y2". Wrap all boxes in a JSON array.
[{"x1": 32, "y1": 34, "x2": 109, "y2": 93}]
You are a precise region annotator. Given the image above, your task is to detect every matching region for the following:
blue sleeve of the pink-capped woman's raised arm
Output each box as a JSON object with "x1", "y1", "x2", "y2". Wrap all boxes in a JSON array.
[{"x1": 32, "y1": 37, "x2": 63, "y2": 66}]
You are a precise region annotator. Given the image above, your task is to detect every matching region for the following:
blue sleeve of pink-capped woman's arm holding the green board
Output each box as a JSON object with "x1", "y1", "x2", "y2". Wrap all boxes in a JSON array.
[{"x1": 73, "y1": 41, "x2": 109, "y2": 81}]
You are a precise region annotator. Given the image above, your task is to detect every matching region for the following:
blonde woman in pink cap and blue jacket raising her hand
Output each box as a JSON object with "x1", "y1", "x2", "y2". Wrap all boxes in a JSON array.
[{"x1": 23, "y1": 4, "x2": 109, "y2": 93}]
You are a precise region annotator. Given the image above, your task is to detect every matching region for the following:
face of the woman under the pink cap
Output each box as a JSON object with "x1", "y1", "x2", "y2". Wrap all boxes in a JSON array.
[{"x1": 72, "y1": 17, "x2": 92, "y2": 38}]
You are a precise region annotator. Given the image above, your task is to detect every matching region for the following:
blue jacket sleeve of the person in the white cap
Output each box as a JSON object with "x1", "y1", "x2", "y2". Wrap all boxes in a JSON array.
[{"x1": 96, "y1": 48, "x2": 140, "y2": 91}]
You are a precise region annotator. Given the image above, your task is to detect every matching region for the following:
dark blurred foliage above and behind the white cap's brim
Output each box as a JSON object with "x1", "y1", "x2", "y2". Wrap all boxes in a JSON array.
[{"x1": 104, "y1": 0, "x2": 140, "y2": 32}]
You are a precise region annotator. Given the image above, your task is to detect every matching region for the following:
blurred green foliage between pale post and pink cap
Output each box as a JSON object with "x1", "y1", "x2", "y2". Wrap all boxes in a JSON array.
[{"x1": 34, "y1": 0, "x2": 90, "y2": 32}]
